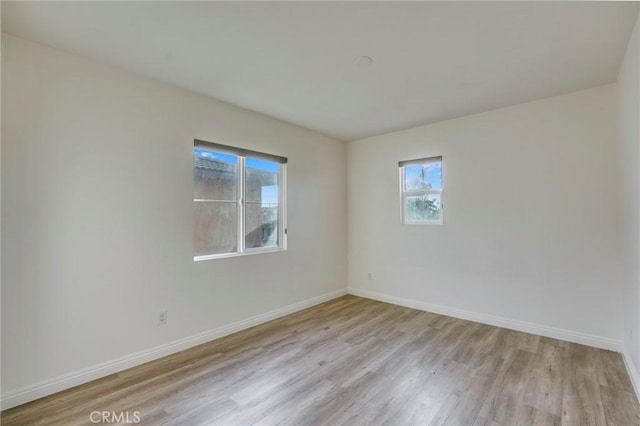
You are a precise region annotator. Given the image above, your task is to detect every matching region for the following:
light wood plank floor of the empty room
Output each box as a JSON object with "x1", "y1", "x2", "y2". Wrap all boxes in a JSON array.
[{"x1": 2, "y1": 296, "x2": 640, "y2": 426}]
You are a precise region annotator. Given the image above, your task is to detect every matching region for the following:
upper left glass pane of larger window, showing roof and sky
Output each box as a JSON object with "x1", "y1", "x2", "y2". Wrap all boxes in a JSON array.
[{"x1": 193, "y1": 148, "x2": 238, "y2": 201}]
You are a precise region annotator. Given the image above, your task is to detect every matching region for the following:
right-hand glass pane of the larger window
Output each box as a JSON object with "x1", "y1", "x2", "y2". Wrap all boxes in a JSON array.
[{"x1": 244, "y1": 158, "x2": 280, "y2": 248}]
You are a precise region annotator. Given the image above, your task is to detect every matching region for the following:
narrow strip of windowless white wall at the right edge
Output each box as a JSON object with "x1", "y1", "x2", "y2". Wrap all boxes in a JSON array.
[{"x1": 617, "y1": 9, "x2": 640, "y2": 393}]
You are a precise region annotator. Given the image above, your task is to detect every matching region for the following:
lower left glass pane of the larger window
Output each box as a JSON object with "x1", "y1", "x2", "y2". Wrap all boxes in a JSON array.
[{"x1": 193, "y1": 201, "x2": 238, "y2": 256}]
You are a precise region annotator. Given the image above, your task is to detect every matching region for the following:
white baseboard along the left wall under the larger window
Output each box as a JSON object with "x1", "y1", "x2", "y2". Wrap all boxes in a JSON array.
[{"x1": 0, "y1": 288, "x2": 347, "y2": 410}]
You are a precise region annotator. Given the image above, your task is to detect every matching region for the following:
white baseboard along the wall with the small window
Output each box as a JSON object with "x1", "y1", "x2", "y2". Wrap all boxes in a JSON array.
[{"x1": 349, "y1": 287, "x2": 622, "y2": 352}]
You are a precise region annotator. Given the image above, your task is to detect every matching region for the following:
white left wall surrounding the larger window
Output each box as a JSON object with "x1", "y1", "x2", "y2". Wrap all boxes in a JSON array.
[{"x1": 2, "y1": 35, "x2": 347, "y2": 402}]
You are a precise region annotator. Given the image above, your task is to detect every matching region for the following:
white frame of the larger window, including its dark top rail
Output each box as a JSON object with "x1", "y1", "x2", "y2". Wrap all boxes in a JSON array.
[{"x1": 193, "y1": 139, "x2": 287, "y2": 262}]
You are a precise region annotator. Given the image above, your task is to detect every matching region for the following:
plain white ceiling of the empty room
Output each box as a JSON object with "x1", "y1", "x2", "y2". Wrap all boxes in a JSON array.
[{"x1": 2, "y1": 2, "x2": 638, "y2": 140}]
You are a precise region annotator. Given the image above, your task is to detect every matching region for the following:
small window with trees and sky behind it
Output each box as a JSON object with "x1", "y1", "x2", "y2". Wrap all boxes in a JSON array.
[{"x1": 398, "y1": 157, "x2": 443, "y2": 225}]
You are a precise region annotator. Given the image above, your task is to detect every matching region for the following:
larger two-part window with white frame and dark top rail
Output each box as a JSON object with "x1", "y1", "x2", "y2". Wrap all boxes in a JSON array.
[{"x1": 193, "y1": 140, "x2": 287, "y2": 260}]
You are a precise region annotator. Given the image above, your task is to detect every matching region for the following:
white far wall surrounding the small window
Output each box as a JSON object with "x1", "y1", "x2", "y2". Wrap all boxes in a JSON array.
[{"x1": 347, "y1": 85, "x2": 622, "y2": 347}]
